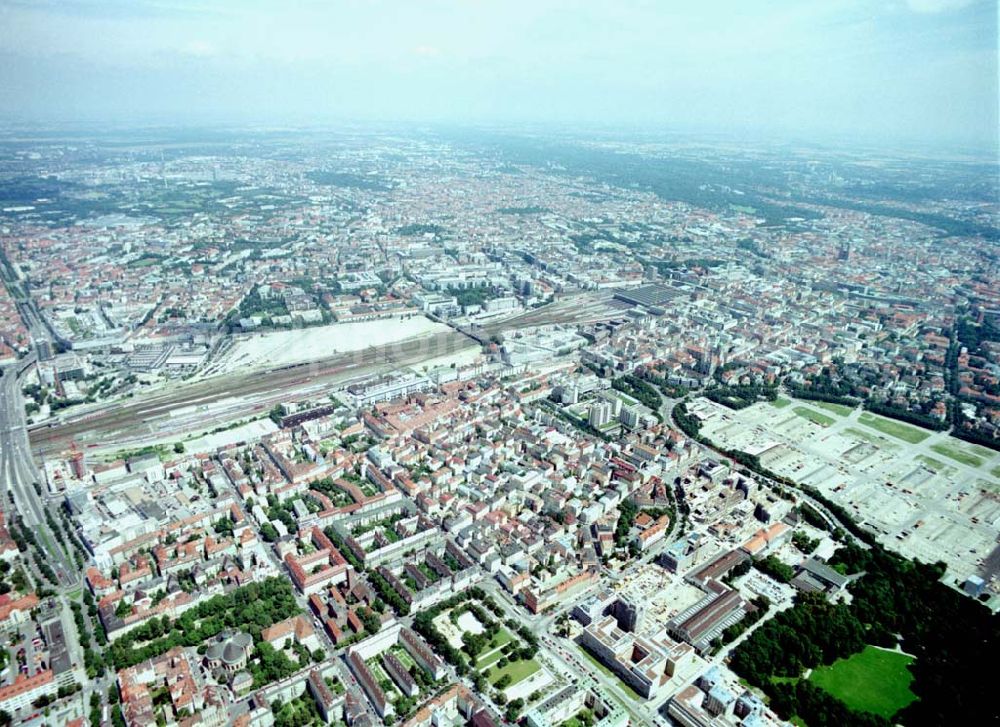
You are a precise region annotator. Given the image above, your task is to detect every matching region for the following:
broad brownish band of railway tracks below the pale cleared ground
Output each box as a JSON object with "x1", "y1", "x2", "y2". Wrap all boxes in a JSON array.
[{"x1": 30, "y1": 331, "x2": 472, "y2": 456}]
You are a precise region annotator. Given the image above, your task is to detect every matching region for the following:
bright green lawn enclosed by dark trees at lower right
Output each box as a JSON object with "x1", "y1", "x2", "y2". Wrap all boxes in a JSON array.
[{"x1": 809, "y1": 646, "x2": 917, "y2": 718}]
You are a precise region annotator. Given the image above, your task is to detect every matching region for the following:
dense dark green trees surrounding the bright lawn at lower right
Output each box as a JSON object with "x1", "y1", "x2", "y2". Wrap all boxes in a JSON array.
[{"x1": 731, "y1": 544, "x2": 1000, "y2": 725}]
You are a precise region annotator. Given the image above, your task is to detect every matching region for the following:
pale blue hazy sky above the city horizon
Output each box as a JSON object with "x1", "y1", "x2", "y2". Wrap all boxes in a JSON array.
[{"x1": 0, "y1": 0, "x2": 998, "y2": 146}]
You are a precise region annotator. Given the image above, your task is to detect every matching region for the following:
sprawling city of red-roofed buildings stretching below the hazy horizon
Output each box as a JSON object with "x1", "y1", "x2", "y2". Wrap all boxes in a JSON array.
[{"x1": 0, "y1": 2, "x2": 1000, "y2": 727}]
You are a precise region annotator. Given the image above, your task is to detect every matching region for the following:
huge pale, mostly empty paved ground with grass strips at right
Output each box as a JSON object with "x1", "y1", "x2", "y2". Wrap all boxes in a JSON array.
[{"x1": 699, "y1": 401, "x2": 1000, "y2": 581}]
